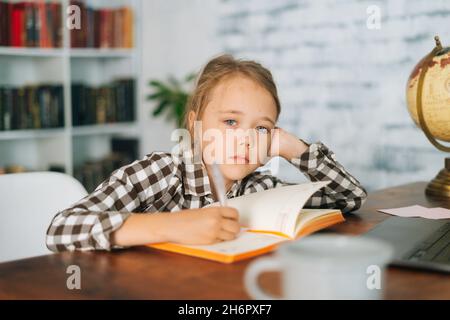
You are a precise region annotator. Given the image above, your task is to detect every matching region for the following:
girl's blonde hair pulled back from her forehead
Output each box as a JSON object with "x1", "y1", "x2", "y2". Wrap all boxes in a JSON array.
[{"x1": 184, "y1": 54, "x2": 281, "y2": 134}]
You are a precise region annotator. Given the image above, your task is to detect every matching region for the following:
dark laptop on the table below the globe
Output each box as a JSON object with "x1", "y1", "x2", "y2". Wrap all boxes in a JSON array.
[{"x1": 362, "y1": 217, "x2": 450, "y2": 273}]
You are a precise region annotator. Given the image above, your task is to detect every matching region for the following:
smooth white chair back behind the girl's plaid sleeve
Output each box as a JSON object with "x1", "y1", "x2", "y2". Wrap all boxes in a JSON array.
[{"x1": 0, "y1": 172, "x2": 87, "y2": 262}]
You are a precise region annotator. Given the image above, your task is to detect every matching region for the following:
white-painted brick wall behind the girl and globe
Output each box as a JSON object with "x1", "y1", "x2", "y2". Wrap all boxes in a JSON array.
[{"x1": 217, "y1": 0, "x2": 450, "y2": 190}]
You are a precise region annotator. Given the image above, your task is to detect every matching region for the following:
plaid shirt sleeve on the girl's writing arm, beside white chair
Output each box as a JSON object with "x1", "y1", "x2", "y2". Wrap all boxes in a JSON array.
[{"x1": 46, "y1": 153, "x2": 175, "y2": 252}]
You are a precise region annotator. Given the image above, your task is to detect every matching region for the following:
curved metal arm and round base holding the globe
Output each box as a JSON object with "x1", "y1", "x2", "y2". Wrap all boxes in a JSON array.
[{"x1": 416, "y1": 36, "x2": 450, "y2": 199}]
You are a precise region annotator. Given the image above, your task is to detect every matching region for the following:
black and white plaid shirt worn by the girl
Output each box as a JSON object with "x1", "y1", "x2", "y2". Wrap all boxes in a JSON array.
[{"x1": 46, "y1": 142, "x2": 367, "y2": 252}]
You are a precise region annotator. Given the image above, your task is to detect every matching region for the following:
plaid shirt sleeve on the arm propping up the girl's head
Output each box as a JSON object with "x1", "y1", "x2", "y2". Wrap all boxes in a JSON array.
[{"x1": 243, "y1": 142, "x2": 367, "y2": 213}]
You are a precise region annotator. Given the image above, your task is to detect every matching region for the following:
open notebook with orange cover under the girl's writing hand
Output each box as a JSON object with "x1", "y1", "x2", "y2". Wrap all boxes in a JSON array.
[{"x1": 147, "y1": 181, "x2": 344, "y2": 263}]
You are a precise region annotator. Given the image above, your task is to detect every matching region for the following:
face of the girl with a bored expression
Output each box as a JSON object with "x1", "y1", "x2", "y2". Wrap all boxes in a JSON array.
[{"x1": 192, "y1": 75, "x2": 277, "y2": 183}]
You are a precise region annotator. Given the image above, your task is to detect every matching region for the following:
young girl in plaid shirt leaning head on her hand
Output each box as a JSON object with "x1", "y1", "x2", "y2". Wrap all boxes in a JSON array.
[{"x1": 46, "y1": 55, "x2": 367, "y2": 251}]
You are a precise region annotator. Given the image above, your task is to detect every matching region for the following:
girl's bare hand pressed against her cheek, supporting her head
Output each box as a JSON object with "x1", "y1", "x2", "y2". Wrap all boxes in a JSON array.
[{"x1": 269, "y1": 127, "x2": 309, "y2": 161}]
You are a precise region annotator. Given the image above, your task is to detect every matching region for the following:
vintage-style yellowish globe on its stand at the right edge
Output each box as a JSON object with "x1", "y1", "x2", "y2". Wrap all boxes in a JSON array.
[{"x1": 406, "y1": 36, "x2": 450, "y2": 198}]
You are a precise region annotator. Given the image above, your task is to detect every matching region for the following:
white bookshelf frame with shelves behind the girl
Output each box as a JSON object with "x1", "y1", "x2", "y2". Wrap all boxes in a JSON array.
[{"x1": 0, "y1": 0, "x2": 143, "y2": 180}]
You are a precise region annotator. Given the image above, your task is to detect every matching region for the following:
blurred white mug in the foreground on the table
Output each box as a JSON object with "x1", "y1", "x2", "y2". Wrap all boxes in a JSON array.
[{"x1": 244, "y1": 235, "x2": 393, "y2": 299}]
